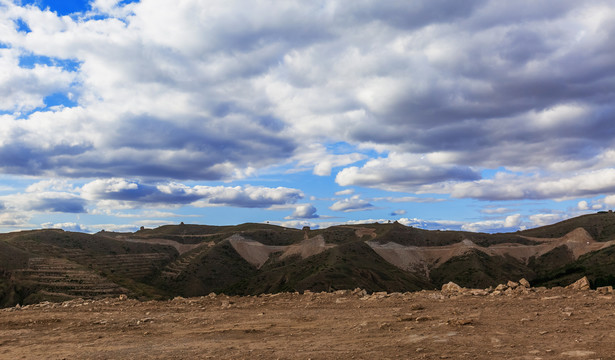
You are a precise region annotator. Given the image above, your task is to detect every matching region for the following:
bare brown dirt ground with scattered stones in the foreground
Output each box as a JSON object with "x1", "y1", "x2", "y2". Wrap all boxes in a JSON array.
[{"x1": 0, "y1": 288, "x2": 615, "y2": 359}]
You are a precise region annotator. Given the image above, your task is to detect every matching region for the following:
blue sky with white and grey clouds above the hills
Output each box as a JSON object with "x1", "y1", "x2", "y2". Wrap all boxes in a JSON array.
[{"x1": 0, "y1": 0, "x2": 615, "y2": 232}]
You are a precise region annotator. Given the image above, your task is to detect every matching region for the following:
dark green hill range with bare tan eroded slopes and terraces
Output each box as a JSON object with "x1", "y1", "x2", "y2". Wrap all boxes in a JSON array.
[{"x1": 0, "y1": 213, "x2": 615, "y2": 306}]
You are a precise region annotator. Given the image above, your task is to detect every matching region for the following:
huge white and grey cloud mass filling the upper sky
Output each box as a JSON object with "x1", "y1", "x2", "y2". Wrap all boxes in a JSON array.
[{"x1": 0, "y1": 0, "x2": 615, "y2": 189}]
